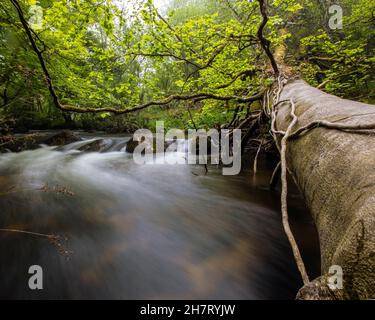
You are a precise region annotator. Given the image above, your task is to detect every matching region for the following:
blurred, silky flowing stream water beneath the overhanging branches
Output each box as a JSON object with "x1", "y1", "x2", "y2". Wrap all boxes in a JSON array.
[{"x1": 0, "y1": 131, "x2": 319, "y2": 299}]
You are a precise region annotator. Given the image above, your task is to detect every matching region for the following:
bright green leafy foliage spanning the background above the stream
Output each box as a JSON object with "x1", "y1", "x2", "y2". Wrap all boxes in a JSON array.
[{"x1": 0, "y1": 0, "x2": 375, "y2": 130}]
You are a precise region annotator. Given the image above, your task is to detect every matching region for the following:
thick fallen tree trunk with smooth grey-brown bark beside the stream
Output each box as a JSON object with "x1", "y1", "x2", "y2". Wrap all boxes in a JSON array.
[{"x1": 275, "y1": 80, "x2": 375, "y2": 299}]
